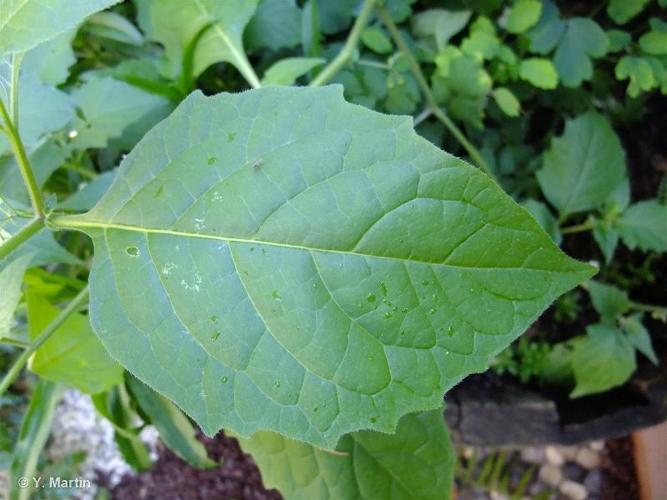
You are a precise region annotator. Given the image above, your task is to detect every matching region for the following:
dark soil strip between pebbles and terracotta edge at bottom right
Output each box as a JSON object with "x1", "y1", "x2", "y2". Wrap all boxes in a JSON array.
[{"x1": 601, "y1": 437, "x2": 639, "y2": 500}]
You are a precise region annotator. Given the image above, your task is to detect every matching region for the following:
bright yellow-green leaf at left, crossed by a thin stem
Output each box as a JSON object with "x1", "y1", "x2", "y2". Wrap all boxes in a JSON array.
[{"x1": 26, "y1": 289, "x2": 123, "y2": 394}]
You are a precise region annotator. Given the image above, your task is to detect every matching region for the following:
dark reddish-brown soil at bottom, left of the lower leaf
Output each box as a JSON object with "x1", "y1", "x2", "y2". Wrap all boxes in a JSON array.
[{"x1": 106, "y1": 432, "x2": 282, "y2": 500}]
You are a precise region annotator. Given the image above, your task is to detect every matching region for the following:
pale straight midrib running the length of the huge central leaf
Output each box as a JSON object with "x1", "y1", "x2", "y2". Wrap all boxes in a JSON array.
[{"x1": 49, "y1": 215, "x2": 582, "y2": 274}]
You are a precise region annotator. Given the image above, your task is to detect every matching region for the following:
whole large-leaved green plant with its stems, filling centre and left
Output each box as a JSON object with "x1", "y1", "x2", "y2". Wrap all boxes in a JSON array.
[{"x1": 0, "y1": 0, "x2": 594, "y2": 498}]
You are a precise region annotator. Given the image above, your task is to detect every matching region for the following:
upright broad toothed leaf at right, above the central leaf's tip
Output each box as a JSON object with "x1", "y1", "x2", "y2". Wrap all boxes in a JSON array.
[{"x1": 537, "y1": 112, "x2": 626, "y2": 218}]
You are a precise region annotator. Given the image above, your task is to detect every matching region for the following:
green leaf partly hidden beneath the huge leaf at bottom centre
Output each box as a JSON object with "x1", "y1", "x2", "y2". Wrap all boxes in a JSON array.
[{"x1": 240, "y1": 410, "x2": 454, "y2": 500}]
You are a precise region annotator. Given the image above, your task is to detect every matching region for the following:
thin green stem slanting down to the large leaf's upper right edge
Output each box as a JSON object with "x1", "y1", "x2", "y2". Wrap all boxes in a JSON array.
[{"x1": 375, "y1": 5, "x2": 495, "y2": 179}]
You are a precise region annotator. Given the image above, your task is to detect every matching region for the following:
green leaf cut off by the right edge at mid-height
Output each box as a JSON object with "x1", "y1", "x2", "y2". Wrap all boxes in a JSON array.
[{"x1": 615, "y1": 200, "x2": 667, "y2": 252}]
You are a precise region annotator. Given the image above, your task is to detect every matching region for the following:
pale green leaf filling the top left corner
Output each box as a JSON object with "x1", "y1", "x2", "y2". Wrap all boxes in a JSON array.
[{"x1": 0, "y1": 0, "x2": 120, "y2": 54}]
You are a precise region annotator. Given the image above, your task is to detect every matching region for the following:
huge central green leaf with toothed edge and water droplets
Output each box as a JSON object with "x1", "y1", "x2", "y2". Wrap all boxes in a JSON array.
[{"x1": 51, "y1": 86, "x2": 592, "y2": 448}]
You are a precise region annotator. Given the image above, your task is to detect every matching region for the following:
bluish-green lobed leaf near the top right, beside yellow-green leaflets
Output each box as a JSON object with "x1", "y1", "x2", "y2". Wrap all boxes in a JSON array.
[{"x1": 554, "y1": 17, "x2": 609, "y2": 87}]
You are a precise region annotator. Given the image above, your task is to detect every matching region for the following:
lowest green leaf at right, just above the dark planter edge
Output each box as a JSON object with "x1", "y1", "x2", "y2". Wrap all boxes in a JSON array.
[{"x1": 570, "y1": 323, "x2": 637, "y2": 398}]
